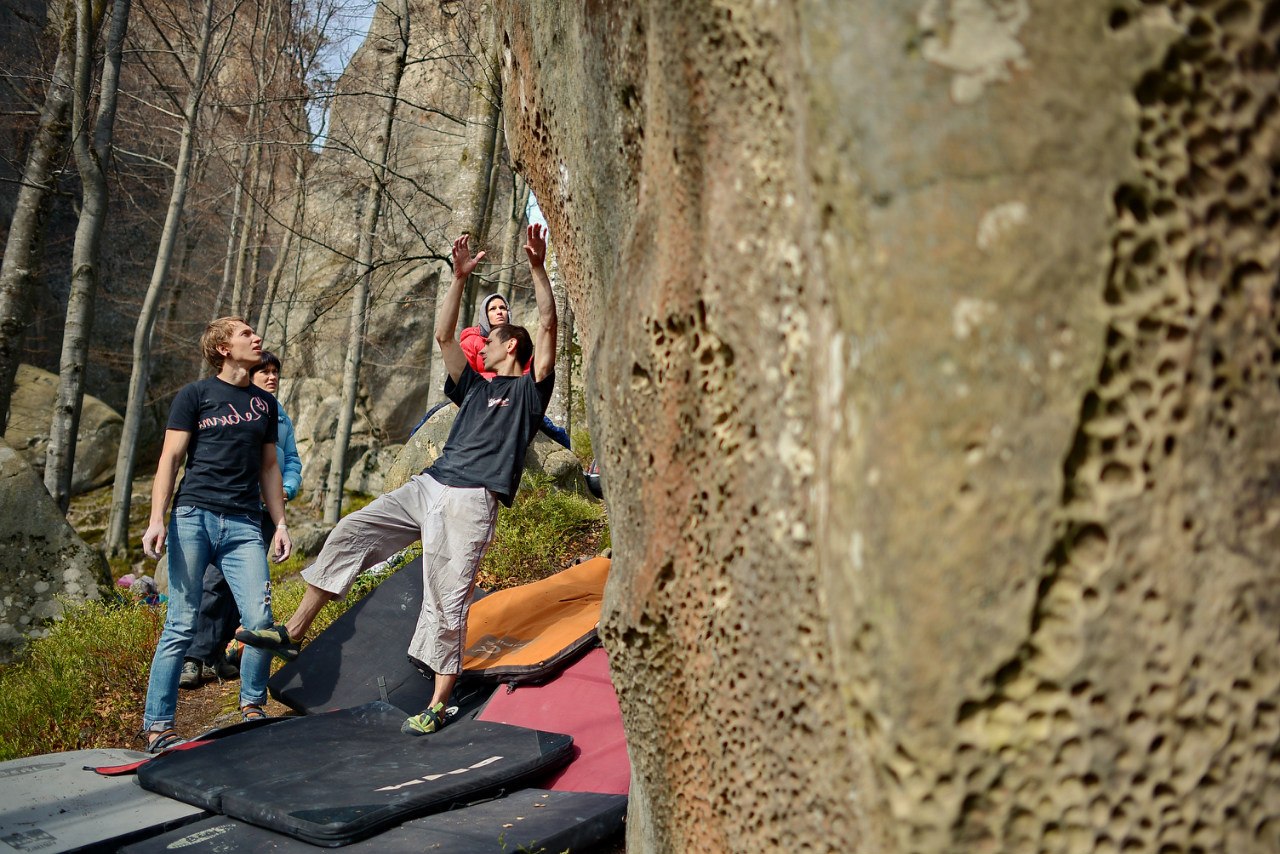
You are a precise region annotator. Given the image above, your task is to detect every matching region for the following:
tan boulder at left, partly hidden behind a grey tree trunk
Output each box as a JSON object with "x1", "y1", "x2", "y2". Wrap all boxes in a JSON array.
[{"x1": 4, "y1": 365, "x2": 124, "y2": 495}]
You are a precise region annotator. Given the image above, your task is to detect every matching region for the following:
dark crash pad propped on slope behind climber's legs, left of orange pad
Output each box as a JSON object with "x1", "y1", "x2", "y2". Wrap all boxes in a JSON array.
[{"x1": 266, "y1": 557, "x2": 493, "y2": 714}]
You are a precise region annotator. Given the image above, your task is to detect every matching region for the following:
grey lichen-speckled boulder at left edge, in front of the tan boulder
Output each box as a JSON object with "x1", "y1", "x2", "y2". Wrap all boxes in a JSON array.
[{"x1": 0, "y1": 443, "x2": 111, "y2": 661}]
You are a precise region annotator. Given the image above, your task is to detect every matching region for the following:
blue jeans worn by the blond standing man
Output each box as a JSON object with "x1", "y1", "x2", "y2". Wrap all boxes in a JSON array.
[{"x1": 142, "y1": 507, "x2": 273, "y2": 731}]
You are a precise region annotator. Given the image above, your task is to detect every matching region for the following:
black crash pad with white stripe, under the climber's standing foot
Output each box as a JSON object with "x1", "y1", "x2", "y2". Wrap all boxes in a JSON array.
[{"x1": 138, "y1": 703, "x2": 573, "y2": 846}]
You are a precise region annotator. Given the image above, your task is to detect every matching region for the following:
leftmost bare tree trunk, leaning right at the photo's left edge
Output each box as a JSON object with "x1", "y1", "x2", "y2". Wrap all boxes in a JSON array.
[{"x1": 0, "y1": 3, "x2": 76, "y2": 433}]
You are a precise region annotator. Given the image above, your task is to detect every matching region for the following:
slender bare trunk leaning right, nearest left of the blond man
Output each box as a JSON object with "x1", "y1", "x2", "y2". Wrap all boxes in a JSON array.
[{"x1": 106, "y1": 0, "x2": 214, "y2": 556}]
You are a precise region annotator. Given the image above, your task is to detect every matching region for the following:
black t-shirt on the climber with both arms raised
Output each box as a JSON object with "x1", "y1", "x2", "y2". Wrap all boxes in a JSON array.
[{"x1": 425, "y1": 365, "x2": 556, "y2": 507}]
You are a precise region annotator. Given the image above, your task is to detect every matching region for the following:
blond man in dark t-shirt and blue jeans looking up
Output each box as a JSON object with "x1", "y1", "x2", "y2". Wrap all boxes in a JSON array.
[{"x1": 142, "y1": 318, "x2": 293, "y2": 753}]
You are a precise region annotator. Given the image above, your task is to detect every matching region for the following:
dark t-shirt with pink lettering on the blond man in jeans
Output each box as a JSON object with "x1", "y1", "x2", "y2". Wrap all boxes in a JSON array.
[{"x1": 168, "y1": 376, "x2": 279, "y2": 519}]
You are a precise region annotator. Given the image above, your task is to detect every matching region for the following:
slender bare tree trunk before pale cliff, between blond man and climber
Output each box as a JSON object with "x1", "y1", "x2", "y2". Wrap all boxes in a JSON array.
[{"x1": 324, "y1": 0, "x2": 408, "y2": 525}]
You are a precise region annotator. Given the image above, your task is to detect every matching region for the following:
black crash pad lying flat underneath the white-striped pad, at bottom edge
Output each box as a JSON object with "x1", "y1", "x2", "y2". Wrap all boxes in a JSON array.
[{"x1": 122, "y1": 789, "x2": 627, "y2": 854}]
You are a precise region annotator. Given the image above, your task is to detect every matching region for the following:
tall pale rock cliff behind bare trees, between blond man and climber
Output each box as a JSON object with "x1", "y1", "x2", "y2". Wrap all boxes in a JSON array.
[{"x1": 264, "y1": 0, "x2": 529, "y2": 460}]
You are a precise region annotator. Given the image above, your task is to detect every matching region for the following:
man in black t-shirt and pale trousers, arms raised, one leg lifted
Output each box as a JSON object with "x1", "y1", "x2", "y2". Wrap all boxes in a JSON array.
[{"x1": 236, "y1": 225, "x2": 557, "y2": 735}]
